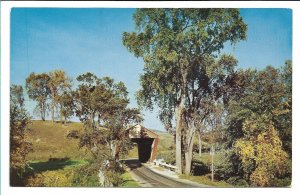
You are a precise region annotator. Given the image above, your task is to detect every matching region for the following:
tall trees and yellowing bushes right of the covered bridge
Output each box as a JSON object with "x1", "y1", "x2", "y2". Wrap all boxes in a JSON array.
[{"x1": 123, "y1": 9, "x2": 292, "y2": 186}]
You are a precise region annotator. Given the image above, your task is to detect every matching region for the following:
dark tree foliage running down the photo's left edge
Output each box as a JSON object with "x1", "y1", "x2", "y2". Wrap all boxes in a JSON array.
[{"x1": 10, "y1": 85, "x2": 32, "y2": 186}]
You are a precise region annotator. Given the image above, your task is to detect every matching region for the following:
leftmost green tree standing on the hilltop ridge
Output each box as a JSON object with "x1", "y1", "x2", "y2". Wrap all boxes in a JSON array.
[{"x1": 26, "y1": 73, "x2": 50, "y2": 121}]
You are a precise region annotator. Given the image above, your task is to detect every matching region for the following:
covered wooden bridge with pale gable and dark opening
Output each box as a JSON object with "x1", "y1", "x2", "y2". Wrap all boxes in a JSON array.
[{"x1": 128, "y1": 125, "x2": 159, "y2": 162}]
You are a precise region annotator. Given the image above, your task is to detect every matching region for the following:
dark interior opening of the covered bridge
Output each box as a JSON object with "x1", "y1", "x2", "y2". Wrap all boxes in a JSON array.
[{"x1": 131, "y1": 138, "x2": 154, "y2": 162}]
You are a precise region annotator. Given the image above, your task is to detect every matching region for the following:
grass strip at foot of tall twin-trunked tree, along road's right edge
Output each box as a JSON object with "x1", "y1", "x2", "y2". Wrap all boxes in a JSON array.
[{"x1": 179, "y1": 174, "x2": 234, "y2": 187}]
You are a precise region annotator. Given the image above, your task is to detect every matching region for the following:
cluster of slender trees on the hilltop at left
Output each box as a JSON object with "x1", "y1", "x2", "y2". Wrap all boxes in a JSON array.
[{"x1": 26, "y1": 70, "x2": 74, "y2": 122}]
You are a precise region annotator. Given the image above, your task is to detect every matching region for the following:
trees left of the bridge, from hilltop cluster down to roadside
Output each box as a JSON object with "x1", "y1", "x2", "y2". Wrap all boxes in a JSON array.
[{"x1": 26, "y1": 70, "x2": 142, "y2": 185}]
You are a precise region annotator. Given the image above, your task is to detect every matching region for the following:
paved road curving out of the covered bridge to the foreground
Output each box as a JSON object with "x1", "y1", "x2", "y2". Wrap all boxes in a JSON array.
[{"x1": 125, "y1": 159, "x2": 195, "y2": 188}]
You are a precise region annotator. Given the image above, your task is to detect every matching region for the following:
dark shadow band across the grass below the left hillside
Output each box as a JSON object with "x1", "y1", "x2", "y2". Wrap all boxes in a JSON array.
[{"x1": 28, "y1": 158, "x2": 80, "y2": 173}]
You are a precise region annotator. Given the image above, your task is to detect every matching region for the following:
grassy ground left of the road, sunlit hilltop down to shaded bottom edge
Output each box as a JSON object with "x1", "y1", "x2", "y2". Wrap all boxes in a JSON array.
[{"x1": 26, "y1": 121, "x2": 138, "y2": 187}]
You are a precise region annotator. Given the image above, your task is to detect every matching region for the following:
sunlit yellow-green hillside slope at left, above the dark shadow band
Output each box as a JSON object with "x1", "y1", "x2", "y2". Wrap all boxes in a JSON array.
[{"x1": 28, "y1": 121, "x2": 89, "y2": 161}]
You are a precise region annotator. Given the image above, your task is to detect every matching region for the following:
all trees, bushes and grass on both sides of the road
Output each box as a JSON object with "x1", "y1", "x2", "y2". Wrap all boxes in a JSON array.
[{"x1": 10, "y1": 9, "x2": 292, "y2": 187}]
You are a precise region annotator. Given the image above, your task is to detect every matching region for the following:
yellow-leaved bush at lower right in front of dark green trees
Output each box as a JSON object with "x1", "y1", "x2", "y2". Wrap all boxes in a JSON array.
[{"x1": 235, "y1": 117, "x2": 288, "y2": 186}]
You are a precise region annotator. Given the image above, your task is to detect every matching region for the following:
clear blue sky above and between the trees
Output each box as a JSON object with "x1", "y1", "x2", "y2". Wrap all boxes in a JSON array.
[{"x1": 10, "y1": 8, "x2": 292, "y2": 130}]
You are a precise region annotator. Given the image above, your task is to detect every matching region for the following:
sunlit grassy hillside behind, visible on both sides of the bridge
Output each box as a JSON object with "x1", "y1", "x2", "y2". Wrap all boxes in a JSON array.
[{"x1": 28, "y1": 121, "x2": 175, "y2": 161}]
